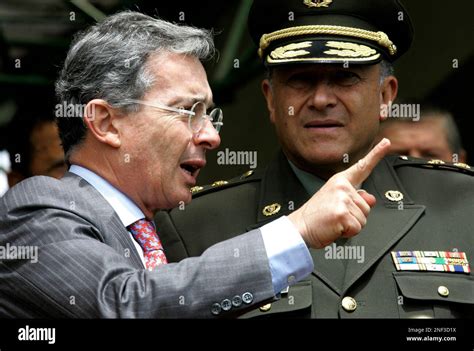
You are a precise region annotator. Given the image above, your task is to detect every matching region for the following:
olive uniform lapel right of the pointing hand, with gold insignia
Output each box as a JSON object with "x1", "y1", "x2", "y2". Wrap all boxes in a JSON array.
[{"x1": 343, "y1": 158, "x2": 425, "y2": 292}]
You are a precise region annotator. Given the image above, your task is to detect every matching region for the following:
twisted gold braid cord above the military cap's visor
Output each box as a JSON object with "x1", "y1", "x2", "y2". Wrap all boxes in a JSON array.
[{"x1": 258, "y1": 25, "x2": 397, "y2": 58}]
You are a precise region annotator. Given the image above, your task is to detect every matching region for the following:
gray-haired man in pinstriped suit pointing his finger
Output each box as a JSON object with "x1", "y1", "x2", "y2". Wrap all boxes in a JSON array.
[{"x1": 0, "y1": 12, "x2": 390, "y2": 318}]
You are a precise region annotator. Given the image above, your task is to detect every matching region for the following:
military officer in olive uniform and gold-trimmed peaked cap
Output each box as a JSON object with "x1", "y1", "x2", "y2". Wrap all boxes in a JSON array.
[{"x1": 156, "y1": 0, "x2": 474, "y2": 318}]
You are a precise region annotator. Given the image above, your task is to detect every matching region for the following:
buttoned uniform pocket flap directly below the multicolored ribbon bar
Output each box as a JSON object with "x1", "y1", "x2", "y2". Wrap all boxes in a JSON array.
[{"x1": 393, "y1": 272, "x2": 474, "y2": 304}]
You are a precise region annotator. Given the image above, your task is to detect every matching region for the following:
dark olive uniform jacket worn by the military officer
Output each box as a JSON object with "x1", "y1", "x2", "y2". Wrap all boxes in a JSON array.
[{"x1": 157, "y1": 154, "x2": 474, "y2": 318}]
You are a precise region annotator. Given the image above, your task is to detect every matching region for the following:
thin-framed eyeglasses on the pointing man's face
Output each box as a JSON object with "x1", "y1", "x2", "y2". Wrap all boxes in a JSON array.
[{"x1": 126, "y1": 99, "x2": 224, "y2": 133}]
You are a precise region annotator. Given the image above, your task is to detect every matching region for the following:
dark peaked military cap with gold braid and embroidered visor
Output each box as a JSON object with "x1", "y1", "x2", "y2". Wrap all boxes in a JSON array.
[{"x1": 248, "y1": 0, "x2": 414, "y2": 66}]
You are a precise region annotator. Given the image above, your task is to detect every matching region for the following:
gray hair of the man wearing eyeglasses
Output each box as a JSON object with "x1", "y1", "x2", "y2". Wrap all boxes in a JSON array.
[{"x1": 56, "y1": 11, "x2": 215, "y2": 160}]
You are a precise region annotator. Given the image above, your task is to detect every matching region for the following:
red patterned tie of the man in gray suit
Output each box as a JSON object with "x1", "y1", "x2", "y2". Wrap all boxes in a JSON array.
[{"x1": 127, "y1": 219, "x2": 168, "y2": 271}]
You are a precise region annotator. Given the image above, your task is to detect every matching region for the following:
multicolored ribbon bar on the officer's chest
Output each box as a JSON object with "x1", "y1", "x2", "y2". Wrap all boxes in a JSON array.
[{"x1": 392, "y1": 251, "x2": 471, "y2": 274}]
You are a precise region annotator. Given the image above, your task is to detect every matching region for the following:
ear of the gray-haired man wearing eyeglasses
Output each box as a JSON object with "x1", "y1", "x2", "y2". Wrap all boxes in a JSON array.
[{"x1": 83, "y1": 99, "x2": 121, "y2": 148}]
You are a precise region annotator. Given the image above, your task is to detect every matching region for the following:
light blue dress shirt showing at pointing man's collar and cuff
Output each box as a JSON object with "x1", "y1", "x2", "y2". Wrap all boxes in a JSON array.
[{"x1": 69, "y1": 165, "x2": 313, "y2": 295}]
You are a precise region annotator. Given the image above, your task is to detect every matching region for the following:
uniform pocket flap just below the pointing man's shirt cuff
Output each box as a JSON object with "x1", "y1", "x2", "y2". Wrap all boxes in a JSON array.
[{"x1": 239, "y1": 280, "x2": 313, "y2": 318}]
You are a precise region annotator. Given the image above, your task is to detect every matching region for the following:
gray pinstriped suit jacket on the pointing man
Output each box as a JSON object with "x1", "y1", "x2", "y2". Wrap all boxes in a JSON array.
[{"x1": 0, "y1": 173, "x2": 274, "y2": 318}]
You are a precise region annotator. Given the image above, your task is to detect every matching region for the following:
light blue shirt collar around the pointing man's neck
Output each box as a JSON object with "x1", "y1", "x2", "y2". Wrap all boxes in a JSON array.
[{"x1": 69, "y1": 165, "x2": 145, "y2": 227}]
